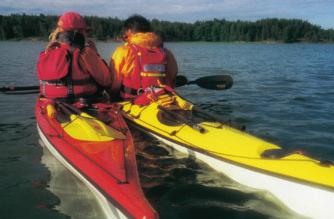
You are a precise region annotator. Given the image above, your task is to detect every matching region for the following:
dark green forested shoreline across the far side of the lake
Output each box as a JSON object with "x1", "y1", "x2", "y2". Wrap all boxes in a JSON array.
[{"x1": 0, "y1": 14, "x2": 334, "y2": 43}]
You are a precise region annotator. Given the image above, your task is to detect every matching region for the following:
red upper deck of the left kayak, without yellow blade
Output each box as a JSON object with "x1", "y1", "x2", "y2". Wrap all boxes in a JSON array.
[{"x1": 36, "y1": 98, "x2": 158, "y2": 219}]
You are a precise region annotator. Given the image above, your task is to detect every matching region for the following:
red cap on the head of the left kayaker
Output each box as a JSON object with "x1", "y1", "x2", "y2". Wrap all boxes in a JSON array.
[{"x1": 57, "y1": 12, "x2": 87, "y2": 30}]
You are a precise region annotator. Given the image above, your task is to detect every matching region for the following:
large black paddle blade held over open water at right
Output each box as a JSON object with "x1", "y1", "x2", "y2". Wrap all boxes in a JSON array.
[{"x1": 191, "y1": 75, "x2": 233, "y2": 90}]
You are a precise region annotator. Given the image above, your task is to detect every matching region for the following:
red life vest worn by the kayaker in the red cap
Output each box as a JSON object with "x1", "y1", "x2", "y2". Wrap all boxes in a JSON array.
[{"x1": 37, "y1": 45, "x2": 97, "y2": 98}]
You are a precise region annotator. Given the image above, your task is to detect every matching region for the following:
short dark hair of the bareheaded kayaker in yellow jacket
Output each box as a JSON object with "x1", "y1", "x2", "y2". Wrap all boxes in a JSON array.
[{"x1": 123, "y1": 15, "x2": 151, "y2": 33}]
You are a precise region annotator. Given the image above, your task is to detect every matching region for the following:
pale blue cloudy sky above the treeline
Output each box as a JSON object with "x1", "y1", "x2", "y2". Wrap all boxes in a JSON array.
[{"x1": 0, "y1": 0, "x2": 334, "y2": 29}]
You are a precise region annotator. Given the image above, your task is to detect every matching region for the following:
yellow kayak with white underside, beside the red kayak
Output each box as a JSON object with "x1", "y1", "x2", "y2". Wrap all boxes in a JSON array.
[{"x1": 119, "y1": 94, "x2": 334, "y2": 218}]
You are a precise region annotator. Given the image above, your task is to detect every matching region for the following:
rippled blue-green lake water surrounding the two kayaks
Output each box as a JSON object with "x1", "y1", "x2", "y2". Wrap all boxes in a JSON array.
[{"x1": 0, "y1": 42, "x2": 334, "y2": 219}]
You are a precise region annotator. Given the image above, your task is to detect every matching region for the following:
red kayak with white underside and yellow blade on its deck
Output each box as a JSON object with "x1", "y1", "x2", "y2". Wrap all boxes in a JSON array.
[{"x1": 36, "y1": 98, "x2": 158, "y2": 219}]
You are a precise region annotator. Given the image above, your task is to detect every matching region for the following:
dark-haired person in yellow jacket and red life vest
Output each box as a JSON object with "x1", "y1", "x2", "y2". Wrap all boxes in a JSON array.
[{"x1": 109, "y1": 15, "x2": 178, "y2": 102}]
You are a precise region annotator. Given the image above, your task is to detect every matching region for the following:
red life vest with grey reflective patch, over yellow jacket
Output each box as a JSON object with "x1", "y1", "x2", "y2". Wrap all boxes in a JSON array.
[{"x1": 121, "y1": 44, "x2": 167, "y2": 98}]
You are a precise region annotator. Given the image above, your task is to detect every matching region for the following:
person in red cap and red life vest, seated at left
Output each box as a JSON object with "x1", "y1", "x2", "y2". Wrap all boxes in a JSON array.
[{"x1": 37, "y1": 12, "x2": 111, "y2": 100}]
